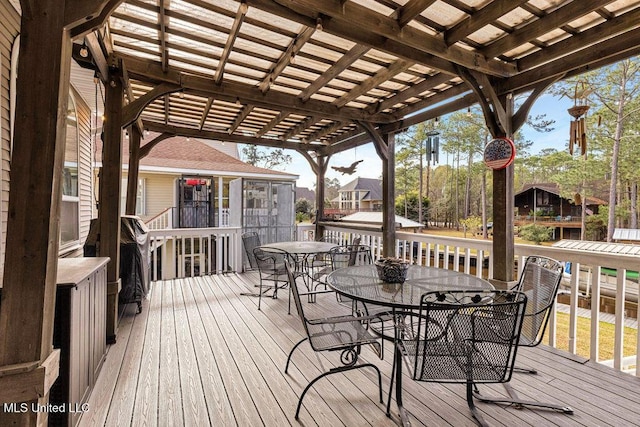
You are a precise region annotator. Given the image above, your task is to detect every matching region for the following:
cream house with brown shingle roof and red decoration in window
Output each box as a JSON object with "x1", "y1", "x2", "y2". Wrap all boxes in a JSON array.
[{"x1": 98, "y1": 135, "x2": 298, "y2": 228}]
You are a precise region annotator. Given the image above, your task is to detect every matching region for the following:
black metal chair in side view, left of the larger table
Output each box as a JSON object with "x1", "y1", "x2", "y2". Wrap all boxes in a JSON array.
[{"x1": 284, "y1": 260, "x2": 383, "y2": 419}]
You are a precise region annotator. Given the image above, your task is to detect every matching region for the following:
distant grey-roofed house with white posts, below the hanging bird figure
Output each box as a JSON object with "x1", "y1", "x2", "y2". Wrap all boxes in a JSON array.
[{"x1": 334, "y1": 178, "x2": 382, "y2": 214}]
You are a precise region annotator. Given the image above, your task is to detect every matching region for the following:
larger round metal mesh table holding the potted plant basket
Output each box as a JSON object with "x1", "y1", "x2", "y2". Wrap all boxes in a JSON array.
[{"x1": 326, "y1": 265, "x2": 493, "y2": 425}]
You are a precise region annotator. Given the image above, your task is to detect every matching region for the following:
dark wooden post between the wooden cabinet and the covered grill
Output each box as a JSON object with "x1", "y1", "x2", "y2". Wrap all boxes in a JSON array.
[{"x1": 98, "y1": 67, "x2": 124, "y2": 342}]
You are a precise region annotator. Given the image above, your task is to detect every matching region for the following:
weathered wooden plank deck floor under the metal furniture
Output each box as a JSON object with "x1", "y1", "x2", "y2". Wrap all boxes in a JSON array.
[{"x1": 80, "y1": 273, "x2": 640, "y2": 427}]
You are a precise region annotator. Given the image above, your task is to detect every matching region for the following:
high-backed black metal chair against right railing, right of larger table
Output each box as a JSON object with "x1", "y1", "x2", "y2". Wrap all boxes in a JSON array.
[{"x1": 476, "y1": 256, "x2": 573, "y2": 414}]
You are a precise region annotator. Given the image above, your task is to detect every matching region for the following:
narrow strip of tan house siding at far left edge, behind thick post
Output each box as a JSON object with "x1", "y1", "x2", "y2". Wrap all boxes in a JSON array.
[{"x1": 0, "y1": 0, "x2": 20, "y2": 286}]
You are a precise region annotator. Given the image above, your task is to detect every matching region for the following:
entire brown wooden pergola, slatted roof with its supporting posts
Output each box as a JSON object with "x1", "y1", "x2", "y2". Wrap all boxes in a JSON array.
[{"x1": 0, "y1": 0, "x2": 640, "y2": 424}]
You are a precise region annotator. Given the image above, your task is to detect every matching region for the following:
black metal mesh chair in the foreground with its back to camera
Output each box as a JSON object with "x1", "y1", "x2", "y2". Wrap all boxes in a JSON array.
[{"x1": 398, "y1": 291, "x2": 527, "y2": 426}]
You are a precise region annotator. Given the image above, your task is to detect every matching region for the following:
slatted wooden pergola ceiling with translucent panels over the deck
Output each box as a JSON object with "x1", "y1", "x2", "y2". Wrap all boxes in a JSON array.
[{"x1": 82, "y1": 0, "x2": 640, "y2": 154}]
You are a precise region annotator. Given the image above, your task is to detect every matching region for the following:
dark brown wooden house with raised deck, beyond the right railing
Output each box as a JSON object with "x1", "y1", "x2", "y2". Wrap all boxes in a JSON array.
[{"x1": 514, "y1": 183, "x2": 607, "y2": 240}]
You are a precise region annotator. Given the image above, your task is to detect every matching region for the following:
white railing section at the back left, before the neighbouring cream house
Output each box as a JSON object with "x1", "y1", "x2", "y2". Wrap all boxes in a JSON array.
[{"x1": 149, "y1": 227, "x2": 242, "y2": 280}]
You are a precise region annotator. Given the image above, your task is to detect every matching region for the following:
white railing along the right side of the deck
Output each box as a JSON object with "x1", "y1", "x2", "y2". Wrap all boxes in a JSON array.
[{"x1": 325, "y1": 225, "x2": 640, "y2": 372}]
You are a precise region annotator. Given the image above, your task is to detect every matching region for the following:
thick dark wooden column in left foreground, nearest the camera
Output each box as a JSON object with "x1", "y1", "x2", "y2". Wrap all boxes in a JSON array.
[{"x1": 0, "y1": 5, "x2": 71, "y2": 425}]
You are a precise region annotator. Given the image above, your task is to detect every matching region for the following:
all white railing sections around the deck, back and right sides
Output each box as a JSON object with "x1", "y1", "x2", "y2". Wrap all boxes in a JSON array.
[{"x1": 149, "y1": 225, "x2": 640, "y2": 376}]
